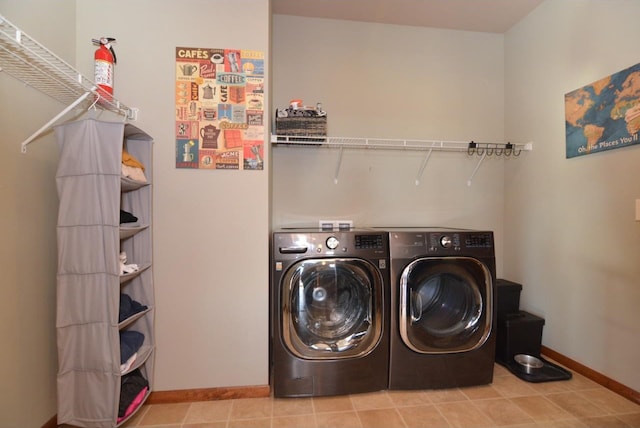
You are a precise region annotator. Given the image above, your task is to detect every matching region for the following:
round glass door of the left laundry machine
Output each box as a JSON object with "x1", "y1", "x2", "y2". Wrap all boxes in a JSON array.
[{"x1": 281, "y1": 258, "x2": 383, "y2": 359}]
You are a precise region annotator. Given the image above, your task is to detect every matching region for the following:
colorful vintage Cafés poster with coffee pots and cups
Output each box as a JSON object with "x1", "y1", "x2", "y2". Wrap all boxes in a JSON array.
[{"x1": 175, "y1": 47, "x2": 265, "y2": 170}]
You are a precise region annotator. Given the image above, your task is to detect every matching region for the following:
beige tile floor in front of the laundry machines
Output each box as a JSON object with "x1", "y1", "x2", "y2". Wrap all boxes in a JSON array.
[{"x1": 96, "y1": 364, "x2": 640, "y2": 428}]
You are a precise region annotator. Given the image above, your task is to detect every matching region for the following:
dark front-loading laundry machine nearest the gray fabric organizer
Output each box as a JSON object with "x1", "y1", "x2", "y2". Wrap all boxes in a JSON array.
[{"x1": 270, "y1": 230, "x2": 389, "y2": 397}]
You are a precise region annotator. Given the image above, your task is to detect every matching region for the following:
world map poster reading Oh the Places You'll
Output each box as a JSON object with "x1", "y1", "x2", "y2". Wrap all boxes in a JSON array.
[{"x1": 564, "y1": 64, "x2": 640, "y2": 159}]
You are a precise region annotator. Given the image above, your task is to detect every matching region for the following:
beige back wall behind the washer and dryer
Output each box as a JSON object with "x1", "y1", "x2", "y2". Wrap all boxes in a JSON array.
[{"x1": 272, "y1": 15, "x2": 510, "y2": 270}]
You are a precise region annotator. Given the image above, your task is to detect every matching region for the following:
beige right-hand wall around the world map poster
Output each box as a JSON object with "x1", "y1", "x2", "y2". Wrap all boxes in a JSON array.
[{"x1": 504, "y1": 0, "x2": 640, "y2": 391}]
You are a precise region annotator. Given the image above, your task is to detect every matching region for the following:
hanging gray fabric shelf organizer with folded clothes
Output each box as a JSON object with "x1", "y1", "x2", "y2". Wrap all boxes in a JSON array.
[{"x1": 55, "y1": 119, "x2": 155, "y2": 427}]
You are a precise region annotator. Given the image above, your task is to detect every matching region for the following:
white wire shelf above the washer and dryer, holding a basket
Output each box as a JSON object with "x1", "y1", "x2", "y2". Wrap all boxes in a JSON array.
[{"x1": 271, "y1": 135, "x2": 533, "y2": 186}]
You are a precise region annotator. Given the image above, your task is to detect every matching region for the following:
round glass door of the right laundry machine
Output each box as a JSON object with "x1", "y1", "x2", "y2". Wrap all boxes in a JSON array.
[{"x1": 399, "y1": 257, "x2": 493, "y2": 354}]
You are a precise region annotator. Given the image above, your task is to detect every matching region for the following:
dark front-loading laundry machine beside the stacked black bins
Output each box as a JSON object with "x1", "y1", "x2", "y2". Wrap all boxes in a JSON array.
[{"x1": 389, "y1": 229, "x2": 495, "y2": 389}]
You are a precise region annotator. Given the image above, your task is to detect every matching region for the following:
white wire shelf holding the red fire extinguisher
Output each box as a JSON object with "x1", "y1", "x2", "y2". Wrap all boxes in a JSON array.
[{"x1": 0, "y1": 15, "x2": 137, "y2": 153}]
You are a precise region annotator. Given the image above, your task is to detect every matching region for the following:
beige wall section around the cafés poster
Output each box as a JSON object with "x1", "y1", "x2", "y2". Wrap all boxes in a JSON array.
[{"x1": 76, "y1": 0, "x2": 270, "y2": 390}]
